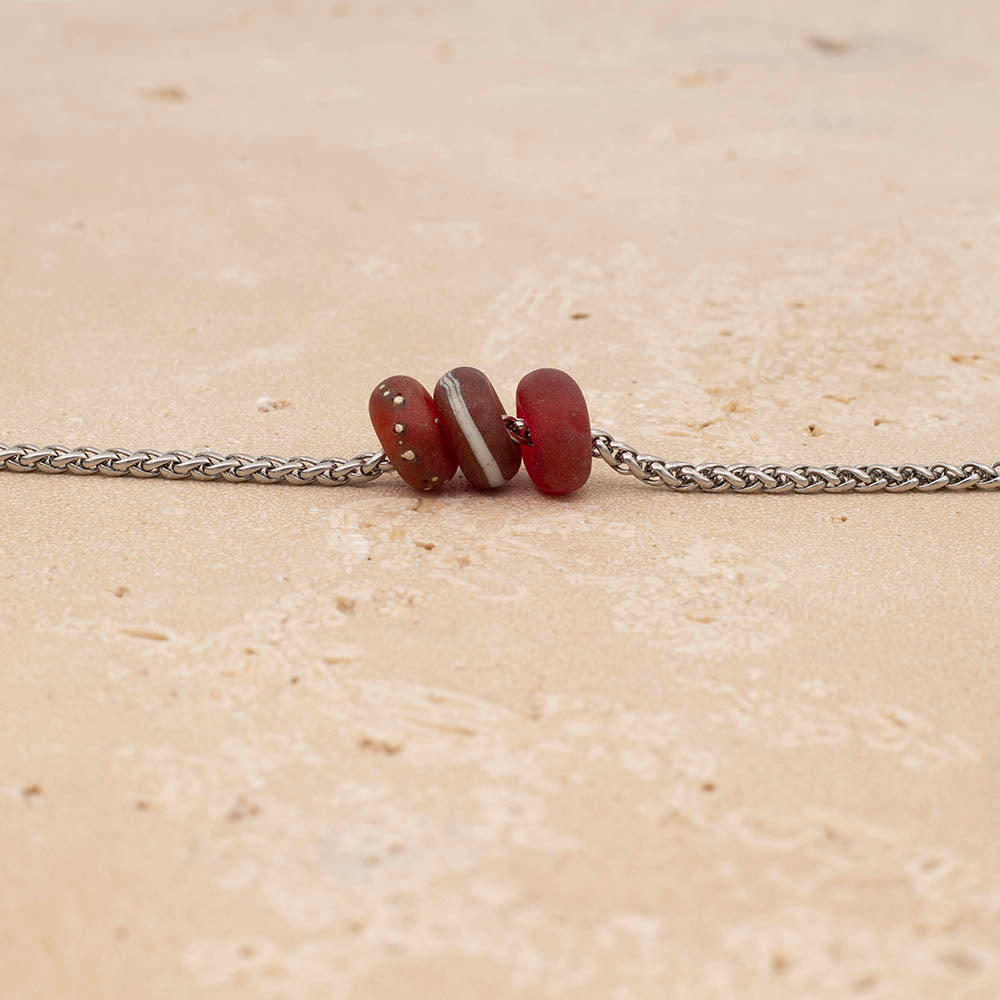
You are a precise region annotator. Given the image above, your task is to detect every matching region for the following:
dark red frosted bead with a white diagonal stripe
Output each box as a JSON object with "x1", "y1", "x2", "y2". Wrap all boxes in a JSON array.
[{"x1": 434, "y1": 368, "x2": 521, "y2": 490}]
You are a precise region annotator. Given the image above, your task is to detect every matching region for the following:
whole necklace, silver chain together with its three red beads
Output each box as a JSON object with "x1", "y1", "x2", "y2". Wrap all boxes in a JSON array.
[{"x1": 0, "y1": 368, "x2": 1000, "y2": 495}]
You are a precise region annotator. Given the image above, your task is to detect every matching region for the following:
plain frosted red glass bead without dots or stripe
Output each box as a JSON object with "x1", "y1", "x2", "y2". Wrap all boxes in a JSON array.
[{"x1": 517, "y1": 368, "x2": 593, "y2": 494}]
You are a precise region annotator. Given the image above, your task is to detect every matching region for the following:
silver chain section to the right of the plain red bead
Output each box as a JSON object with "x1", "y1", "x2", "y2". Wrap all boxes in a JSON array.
[{"x1": 591, "y1": 428, "x2": 1000, "y2": 493}]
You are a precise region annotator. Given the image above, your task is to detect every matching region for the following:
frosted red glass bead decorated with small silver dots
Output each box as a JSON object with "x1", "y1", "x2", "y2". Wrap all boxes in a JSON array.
[{"x1": 368, "y1": 375, "x2": 458, "y2": 490}]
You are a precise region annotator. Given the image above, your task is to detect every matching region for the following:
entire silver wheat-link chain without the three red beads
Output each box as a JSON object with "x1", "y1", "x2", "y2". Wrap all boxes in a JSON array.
[{"x1": 0, "y1": 434, "x2": 1000, "y2": 493}]
